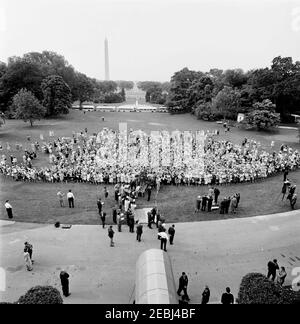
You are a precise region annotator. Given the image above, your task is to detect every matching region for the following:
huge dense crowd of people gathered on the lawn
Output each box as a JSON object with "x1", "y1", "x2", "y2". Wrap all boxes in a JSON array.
[{"x1": 0, "y1": 129, "x2": 300, "y2": 186}]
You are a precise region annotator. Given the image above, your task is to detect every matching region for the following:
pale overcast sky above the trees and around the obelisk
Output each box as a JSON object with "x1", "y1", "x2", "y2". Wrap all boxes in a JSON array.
[{"x1": 0, "y1": 0, "x2": 300, "y2": 81}]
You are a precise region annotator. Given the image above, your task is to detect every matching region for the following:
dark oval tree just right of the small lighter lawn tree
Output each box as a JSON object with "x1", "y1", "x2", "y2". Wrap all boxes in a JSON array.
[{"x1": 41, "y1": 75, "x2": 72, "y2": 116}]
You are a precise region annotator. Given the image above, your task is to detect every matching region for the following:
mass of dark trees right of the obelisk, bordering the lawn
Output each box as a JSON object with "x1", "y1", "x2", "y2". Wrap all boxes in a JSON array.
[{"x1": 166, "y1": 56, "x2": 300, "y2": 128}]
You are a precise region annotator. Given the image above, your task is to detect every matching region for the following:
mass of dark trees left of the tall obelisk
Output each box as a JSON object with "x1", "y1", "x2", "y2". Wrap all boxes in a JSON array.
[{"x1": 0, "y1": 51, "x2": 134, "y2": 125}]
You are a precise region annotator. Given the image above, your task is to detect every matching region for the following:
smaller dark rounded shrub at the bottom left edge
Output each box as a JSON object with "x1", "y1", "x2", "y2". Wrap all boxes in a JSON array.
[{"x1": 18, "y1": 286, "x2": 63, "y2": 304}]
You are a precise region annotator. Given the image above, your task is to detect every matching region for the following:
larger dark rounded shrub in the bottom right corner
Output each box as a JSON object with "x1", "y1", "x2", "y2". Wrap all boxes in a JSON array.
[{"x1": 237, "y1": 273, "x2": 300, "y2": 304}]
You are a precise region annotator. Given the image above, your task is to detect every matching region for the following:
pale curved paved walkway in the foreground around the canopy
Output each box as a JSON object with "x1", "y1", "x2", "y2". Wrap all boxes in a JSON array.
[{"x1": 0, "y1": 211, "x2": 300, "y2": 304}]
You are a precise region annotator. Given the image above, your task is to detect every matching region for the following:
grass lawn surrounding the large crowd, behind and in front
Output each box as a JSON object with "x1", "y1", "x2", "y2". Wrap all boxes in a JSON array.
[{"x1": 0, "y1": 111, "x2": 300, "y2": 224}]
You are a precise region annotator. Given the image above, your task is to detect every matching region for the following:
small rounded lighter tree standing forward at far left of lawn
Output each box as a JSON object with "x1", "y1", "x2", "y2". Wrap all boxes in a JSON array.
[{"x1": 11, "y1": 89, "x2": 46, "y2": 127}]
